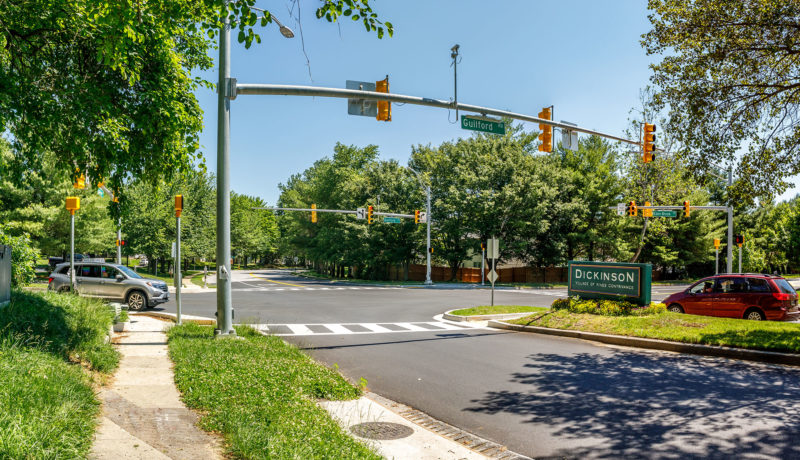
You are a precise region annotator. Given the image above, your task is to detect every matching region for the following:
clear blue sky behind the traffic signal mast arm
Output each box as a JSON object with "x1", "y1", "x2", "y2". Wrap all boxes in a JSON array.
[{"x1": 197, "y1": 0, "x2": 797, "y2": 205}]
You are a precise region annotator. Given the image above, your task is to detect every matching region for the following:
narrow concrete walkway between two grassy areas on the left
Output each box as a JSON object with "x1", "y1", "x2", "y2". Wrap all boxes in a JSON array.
[{"x1": 90, "y1": 315, "x2": 222, "y2": 460}]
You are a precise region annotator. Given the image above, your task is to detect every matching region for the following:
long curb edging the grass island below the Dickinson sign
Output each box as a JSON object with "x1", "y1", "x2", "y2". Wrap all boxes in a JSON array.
[{"x1": 487, "y1": 321, "x2": 800, "y2": 366}]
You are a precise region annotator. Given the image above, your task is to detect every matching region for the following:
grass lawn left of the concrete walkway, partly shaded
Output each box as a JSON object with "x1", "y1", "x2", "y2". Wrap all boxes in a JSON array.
[{"x1": 0, "y1": 290, "x2": 119, "y2": 458}]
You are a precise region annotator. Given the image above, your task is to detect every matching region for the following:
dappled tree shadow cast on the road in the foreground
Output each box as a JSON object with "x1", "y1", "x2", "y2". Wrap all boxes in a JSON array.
[{"x1": 465, "y1": 350, "x2": 800, "y2": 458}]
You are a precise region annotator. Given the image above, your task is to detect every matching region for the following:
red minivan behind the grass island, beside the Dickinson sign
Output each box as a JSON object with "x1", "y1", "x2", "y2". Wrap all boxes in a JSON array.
[{"x1": 664, "y1": 273, "x2": 800, "y2": 321}]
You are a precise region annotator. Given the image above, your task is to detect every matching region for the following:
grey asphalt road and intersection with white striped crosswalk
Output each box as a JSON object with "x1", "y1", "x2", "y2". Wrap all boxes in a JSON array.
[{"x1": 159, "y1": 271, "x2": 800, "y2": 458}]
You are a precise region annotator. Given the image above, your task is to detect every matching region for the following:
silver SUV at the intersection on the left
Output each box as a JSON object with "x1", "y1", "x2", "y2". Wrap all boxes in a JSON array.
[{"x1": 47, "y1": 262, "x2": 169, "y2": 310}]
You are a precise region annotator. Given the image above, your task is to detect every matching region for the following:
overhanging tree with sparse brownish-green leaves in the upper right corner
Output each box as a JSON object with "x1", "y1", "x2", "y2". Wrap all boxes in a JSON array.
[{"x1": 642, "y1": 0, "x2": 800, "y2": 200}]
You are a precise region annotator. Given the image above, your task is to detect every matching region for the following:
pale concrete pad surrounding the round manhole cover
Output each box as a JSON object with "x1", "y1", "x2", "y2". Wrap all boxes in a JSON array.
[{"x1": 320, "y1": 397, "x2": 489, "y2": 460}]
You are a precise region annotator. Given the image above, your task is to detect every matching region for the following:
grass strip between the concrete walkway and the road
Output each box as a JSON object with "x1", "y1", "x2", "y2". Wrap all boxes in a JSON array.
[{"x1": 168, "y1": 324, "x2": 381, "y2": 459}]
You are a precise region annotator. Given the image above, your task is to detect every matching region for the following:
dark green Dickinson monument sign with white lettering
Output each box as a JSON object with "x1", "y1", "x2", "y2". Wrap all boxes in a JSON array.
[{"x1": 568, "y1": 260, "x2": 653, "y2": 305}]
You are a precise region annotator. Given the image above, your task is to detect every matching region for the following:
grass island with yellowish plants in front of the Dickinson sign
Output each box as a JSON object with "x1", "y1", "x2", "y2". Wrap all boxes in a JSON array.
[{"x1": 508, "y1": 310, "x2": 800, "y2": 353}]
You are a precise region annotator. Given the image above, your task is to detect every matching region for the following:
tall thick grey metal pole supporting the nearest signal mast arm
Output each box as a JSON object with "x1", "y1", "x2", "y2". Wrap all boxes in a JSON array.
[{"x1": 214, "y1": 0, "x2": 236, "y2": 337}]
